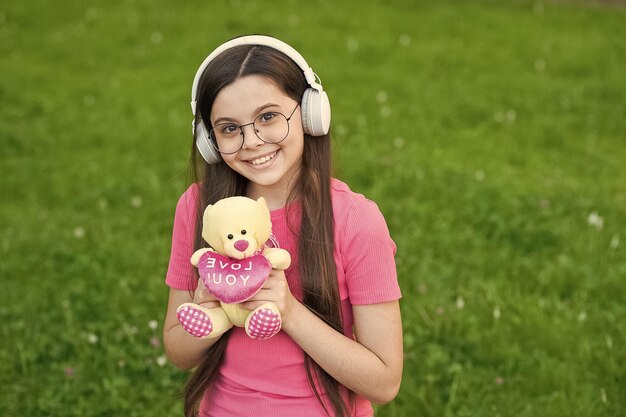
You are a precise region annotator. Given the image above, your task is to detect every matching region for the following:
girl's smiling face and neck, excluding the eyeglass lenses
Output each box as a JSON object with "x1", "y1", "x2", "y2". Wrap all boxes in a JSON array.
[{"x1": 210, "y1": 75, "x2": 304, "y2": 204}]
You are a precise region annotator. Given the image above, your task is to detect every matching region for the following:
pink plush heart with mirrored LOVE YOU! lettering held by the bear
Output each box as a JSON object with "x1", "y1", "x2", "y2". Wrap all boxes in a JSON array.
[{"x1": 198, "y1": 252, "x2": 272, "y2": 304}]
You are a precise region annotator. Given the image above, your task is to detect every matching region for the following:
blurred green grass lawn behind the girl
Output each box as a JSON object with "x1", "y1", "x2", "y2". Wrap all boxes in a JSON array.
[{"x1": 0, "y1": 0, "x2": 626, "y2": 416}]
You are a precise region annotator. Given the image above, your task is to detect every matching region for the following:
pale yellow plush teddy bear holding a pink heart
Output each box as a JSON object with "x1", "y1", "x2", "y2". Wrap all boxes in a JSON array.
[{"x1": 176, "y1": 197, "x2": 291, "y2": 339}]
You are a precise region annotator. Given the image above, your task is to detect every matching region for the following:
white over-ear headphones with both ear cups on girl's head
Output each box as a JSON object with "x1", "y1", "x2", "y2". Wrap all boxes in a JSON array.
[{"x1": 191, "y1": 35, "x2": 330, "y2": 164}]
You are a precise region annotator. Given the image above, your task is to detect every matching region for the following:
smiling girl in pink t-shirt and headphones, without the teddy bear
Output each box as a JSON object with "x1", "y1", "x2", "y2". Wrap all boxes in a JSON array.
[{"x1": 164, "y1": 36, "x2": 403, "y2": 417}]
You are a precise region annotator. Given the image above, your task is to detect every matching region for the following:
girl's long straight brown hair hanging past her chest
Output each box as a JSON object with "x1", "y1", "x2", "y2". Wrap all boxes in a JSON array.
[{"x1": 183, "y1": 45, "x2": 353, "y2": 417}]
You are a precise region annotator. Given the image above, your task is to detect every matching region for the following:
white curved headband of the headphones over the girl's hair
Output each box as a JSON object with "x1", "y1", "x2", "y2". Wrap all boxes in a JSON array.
[{"x1": 191, "y1": 35, "x2": 323, "y2": 116}]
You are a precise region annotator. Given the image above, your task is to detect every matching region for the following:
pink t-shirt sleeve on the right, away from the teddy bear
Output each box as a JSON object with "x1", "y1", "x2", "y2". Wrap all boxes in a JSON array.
[{"x1": 343, "y1": 199, "x2": 402, "y2": 305}]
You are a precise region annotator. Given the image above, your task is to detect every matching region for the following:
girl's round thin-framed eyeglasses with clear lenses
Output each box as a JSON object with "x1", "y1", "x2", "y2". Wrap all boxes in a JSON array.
[{"x1": 209, "y1": 104, "x2": 300, "y2": 154}]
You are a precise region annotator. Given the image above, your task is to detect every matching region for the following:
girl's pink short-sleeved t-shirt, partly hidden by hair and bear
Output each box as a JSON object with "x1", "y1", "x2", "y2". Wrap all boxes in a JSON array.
[{"x1": 166, "y1": 179, "x2": 401, "y2": 417}]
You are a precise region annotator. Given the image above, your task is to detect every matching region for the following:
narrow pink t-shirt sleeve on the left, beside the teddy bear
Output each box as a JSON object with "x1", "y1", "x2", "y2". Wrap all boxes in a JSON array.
[{"x1": 165, "y1": 184, "x2": 198, "y2": 291}]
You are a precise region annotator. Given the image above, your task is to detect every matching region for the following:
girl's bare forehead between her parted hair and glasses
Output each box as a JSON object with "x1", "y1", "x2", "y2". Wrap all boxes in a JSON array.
[{"x1": 211, "y1": 75, "x2": 293, "y2": 120}]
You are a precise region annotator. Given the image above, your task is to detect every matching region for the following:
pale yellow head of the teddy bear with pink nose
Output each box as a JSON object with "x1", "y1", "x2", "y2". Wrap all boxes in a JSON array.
[{"x1": 202, "y1": 197, "x2": 272, "y2": 259}]
